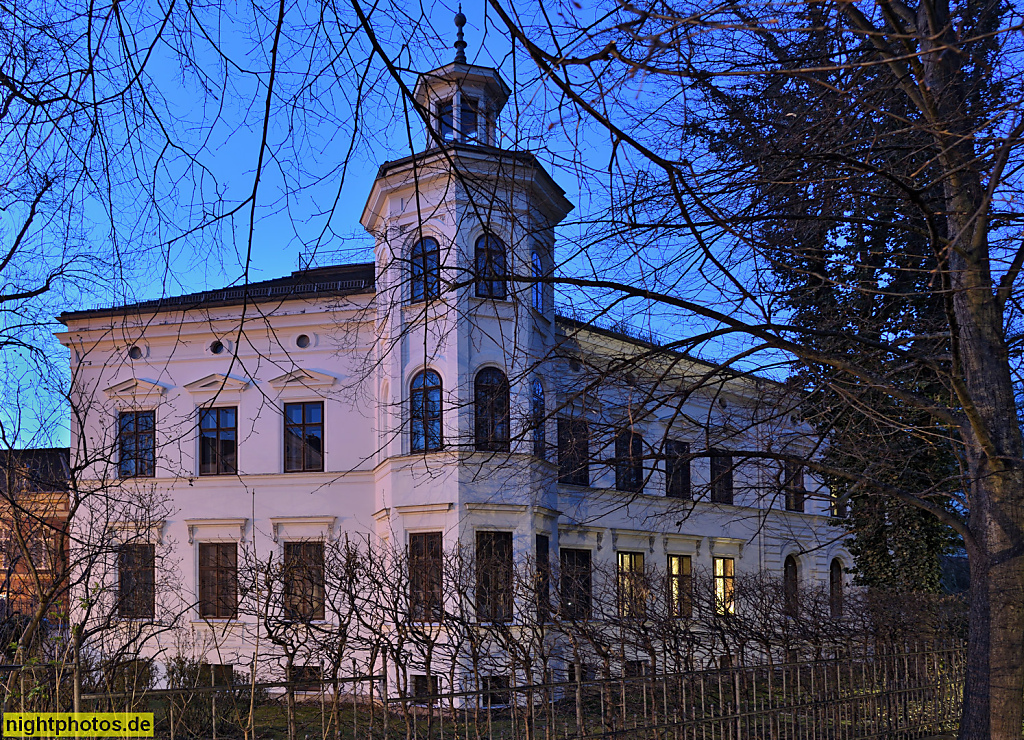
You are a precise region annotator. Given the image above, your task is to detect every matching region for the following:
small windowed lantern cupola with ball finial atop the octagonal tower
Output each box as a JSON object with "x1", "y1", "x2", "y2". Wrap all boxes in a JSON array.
[{"x1": 414, "y1": 6, "x2": 512, "y2": 148}]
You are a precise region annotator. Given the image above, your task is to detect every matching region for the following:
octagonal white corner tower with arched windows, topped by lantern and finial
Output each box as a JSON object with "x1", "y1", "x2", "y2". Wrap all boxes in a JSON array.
[{"x1": 360, "y1": 12, "x2": 572, "y2": 530}]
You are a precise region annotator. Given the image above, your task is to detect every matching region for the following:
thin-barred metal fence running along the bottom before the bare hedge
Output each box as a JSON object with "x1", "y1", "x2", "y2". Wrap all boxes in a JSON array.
[{"x1": 5, "y1": 646, "x2": 965, "y2": 740}]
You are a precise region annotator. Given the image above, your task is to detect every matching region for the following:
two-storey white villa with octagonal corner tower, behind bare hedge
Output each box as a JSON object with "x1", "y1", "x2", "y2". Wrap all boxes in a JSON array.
[{"x1": 59, "y1": 32, "x2": 852, "y2": 691}]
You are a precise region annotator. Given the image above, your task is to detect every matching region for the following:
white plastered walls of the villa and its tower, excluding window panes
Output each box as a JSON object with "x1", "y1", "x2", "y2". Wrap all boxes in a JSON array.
[{"x1": 54, "y1": 63, "x2": 851, "y2": 679}]
